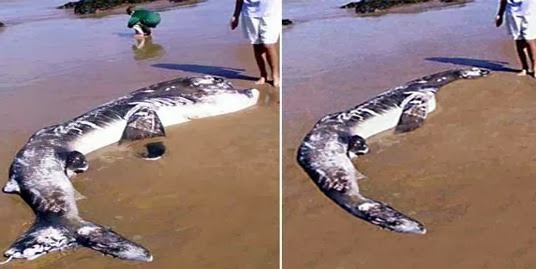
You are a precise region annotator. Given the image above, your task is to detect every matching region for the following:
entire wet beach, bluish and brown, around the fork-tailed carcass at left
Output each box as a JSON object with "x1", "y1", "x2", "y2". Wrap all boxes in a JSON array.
[{"x1": 0, "y1": 1, "x2": 279, "y2": 268}]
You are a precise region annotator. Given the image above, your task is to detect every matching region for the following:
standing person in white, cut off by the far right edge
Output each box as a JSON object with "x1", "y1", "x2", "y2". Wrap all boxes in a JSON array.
[{"x1": 495, "y1": 0, "x2": 536, "y2": 77}]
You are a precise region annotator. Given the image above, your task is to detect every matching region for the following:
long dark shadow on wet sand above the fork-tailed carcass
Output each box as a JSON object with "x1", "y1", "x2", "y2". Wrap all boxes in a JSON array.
[{"x1": 153, "y1": 63, "x2": 258, "y2": 81}]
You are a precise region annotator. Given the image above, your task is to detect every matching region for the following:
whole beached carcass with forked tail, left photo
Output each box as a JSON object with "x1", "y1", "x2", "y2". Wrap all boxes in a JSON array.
[{"x1": 3, "y1": 76, "x2": 258, "y2": 261}]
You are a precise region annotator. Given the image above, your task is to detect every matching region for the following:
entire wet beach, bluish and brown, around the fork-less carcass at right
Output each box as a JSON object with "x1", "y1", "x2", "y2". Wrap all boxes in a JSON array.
[{"x1": 283, "y1": 1, "x2": 536, "y2": 268}]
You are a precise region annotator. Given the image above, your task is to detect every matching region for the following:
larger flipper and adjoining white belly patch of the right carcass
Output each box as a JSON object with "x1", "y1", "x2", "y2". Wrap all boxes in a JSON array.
[{"x1": 395, "y1": 93, "x2": 435, "y2": 133}]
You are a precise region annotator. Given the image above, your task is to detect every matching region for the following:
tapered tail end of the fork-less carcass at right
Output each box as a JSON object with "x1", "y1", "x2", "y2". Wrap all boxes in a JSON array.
[{"x1": 326, "y1": 191, "x2": 426, "y2": 234}]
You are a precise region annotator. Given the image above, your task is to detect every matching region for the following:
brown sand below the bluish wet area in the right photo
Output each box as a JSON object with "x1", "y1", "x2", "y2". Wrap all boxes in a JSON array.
[{"x1": 284, "y1": 74, "x2": 536, "y2": 268}]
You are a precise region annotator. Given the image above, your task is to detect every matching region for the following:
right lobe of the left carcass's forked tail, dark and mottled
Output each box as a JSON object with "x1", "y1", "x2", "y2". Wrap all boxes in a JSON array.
[{"x1": 76, "y1": 222, "x2": 153, "y2": 262}]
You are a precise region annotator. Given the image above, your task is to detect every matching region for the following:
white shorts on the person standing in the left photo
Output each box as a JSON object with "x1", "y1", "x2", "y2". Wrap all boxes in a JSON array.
[{"x1": 242, "y1": 16, "x2": 281, "y2": 44}]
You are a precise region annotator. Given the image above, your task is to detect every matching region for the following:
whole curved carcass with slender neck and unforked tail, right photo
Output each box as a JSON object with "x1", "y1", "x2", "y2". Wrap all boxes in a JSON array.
[{"x1": 297, "y1": 68, "x2": 489, "y2": 234}]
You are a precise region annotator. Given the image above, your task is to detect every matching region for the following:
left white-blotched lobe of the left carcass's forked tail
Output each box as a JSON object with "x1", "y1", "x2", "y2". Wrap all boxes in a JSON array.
[{"x1": 4, "y1": 220, "x2": 77, "y2": 260}]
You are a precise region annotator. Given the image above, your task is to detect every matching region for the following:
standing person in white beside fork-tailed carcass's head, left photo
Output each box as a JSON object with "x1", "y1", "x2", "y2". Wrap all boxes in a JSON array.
[{"x1": 230, "y1": 0, "x2": 281, "y2": 87}]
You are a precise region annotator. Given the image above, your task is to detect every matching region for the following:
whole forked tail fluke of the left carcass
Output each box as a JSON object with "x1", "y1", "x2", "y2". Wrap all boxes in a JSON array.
[{"x1": 4, "y1": 217, "x2": 153, "y2": 262}]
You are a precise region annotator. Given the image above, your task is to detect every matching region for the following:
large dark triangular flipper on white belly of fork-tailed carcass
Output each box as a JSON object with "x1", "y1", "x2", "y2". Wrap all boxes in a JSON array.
[{"x1": 120, "y1": 107, "x2": 166, "y2": 143}]
